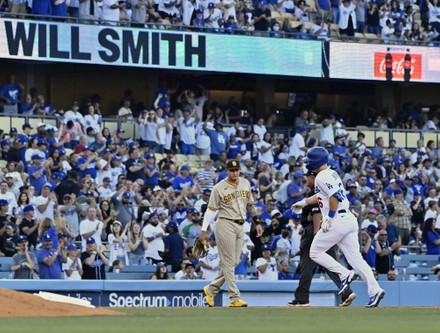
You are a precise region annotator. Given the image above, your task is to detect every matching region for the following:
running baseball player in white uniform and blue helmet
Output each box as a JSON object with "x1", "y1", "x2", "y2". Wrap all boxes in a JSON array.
[{"x1": 292, "y1": 147, "x2": 385, "y2": 308}]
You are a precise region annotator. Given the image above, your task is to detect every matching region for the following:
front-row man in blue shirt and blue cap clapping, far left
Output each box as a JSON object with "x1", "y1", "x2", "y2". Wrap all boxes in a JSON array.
[{"x1": 37, "y1": 234, "x2": 67, "y2": 280}]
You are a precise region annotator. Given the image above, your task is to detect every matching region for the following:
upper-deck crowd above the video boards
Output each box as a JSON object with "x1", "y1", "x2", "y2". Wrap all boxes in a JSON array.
[{"x1": 0, "y1": 0, "x2": 440, "y2": 42}]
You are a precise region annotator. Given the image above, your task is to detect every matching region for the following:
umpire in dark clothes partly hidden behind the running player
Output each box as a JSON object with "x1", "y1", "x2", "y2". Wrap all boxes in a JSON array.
[{"x1": 288, "y1": 171, "x2": 356, "y2": 307}]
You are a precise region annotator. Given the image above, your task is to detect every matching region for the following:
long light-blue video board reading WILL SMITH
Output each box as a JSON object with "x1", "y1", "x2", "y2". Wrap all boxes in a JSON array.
[{"x1": 0, "y1": 18, "x2": 322, "y2": 77}]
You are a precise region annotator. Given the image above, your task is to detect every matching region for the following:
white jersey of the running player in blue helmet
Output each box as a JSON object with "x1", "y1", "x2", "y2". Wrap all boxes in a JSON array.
[{"x1": 315, "y1": 169, "x2": 350, "y2": 216}]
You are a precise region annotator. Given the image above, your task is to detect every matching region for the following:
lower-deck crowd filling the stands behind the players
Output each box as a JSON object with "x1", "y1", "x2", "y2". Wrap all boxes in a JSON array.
[{"x1": 0, "y1": 72, "x2": 440, "y2": 281}]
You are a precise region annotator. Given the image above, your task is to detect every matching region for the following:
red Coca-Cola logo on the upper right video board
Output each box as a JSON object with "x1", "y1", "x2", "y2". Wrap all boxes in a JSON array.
[{"x1": 374, "y1": 52, "x2": 422, "y2": 80}]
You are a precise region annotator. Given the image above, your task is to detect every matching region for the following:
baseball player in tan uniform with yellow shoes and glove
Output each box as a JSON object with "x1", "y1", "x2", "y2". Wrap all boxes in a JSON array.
[{"x1": 200, "y1": 160, "x2": 264, "y2": 307}]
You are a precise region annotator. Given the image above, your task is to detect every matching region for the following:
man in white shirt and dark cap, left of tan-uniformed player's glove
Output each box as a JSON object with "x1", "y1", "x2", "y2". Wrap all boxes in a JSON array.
[{"x1": 142, "y1": 212, "x2": 165, "y2": 264}]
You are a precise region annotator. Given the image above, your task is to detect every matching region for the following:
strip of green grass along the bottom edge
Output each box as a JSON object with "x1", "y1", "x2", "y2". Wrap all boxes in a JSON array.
[{"x1": 0, "y1": 307, "x2": 440, "y2": 333}]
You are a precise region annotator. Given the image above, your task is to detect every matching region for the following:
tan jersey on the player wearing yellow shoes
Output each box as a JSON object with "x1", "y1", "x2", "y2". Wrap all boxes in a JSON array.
[{"x1": 208, "y1": 177, "x2": 254, "y2": 220}]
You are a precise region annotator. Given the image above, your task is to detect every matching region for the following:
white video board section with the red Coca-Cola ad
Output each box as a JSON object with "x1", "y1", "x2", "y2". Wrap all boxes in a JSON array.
[{"x1": 329, "y1": 42, "x2": 440, "y2": 82}]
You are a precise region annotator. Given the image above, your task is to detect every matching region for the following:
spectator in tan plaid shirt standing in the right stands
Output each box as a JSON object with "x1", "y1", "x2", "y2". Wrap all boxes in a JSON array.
[{"x1": 390, "y1": 189, "x2": 412, "y2": 245}]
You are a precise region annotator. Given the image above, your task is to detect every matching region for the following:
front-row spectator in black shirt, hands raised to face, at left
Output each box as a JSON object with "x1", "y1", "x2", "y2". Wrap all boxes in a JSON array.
[{"x1": 81, "y1": 237, "x2": 110, "y2": 280}]
